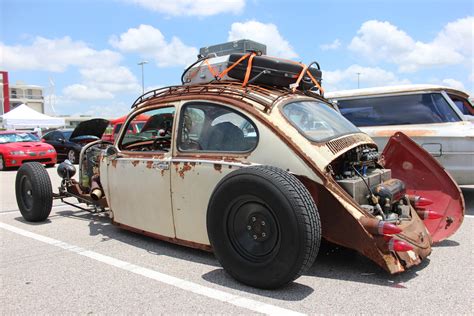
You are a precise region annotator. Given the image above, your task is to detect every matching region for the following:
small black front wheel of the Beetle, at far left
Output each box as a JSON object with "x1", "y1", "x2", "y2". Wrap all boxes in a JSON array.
[{"x1": 15, "y1": 162, "x2": 53, "y2": 222}]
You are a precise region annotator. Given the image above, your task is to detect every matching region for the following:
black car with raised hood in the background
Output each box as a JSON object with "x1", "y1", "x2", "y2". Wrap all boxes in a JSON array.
[{"x1": 42, "y1": 119, "x2": 109, "y2": 164}]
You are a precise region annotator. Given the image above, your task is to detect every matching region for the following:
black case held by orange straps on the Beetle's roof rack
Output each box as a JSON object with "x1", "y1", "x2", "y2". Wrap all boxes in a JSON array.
[{"x1": 227, "y1": 54, "x2": 322, "y2": 90}]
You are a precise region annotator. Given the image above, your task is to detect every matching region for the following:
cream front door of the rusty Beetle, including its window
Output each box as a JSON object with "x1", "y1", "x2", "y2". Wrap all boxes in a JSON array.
[{"x1": 106, "y1": 105, "x2": 175, "y2": 238}]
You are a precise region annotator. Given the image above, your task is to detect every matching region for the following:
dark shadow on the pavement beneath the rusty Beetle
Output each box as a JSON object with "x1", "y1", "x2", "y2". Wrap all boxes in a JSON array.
[{"x1": 16, "y1": 206, "x2": 436, "y2": 301}]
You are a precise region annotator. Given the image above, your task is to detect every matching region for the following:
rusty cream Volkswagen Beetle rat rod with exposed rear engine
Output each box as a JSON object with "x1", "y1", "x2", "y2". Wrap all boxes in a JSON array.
[{"x1": 16, "y1": 47, "x2": 464, "y2": 288}]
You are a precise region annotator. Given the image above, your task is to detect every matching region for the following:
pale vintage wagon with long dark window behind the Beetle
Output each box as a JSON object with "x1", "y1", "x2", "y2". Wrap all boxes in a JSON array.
[{"x1": 325, "y1": 85, "x2": 474, "y2": 184}]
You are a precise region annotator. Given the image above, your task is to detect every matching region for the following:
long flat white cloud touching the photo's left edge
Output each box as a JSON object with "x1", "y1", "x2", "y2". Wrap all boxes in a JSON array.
[{"x1": 0, "y1": 36, "x2": 122, "y2": 72}]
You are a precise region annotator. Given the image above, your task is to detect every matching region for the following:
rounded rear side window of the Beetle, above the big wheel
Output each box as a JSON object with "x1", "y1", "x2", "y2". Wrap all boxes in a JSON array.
[{"x1": 178, "y1": 103, "x2": 258, "y2": 152}]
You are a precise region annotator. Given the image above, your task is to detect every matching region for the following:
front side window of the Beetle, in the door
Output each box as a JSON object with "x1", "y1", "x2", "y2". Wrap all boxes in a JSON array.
[{"x1": 119, "y1": 107, "x2": 175, "y2": 152}]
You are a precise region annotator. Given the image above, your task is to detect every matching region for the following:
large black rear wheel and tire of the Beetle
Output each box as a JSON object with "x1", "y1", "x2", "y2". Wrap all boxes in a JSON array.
[{"x1": 207, "y1": 166, "x2": 321, "y2": 289}]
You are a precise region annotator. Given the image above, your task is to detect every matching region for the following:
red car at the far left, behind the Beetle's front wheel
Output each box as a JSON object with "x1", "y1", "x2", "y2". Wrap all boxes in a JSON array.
[{"x1": 0, "y1": 131, "x2": 56, "y2": 170}]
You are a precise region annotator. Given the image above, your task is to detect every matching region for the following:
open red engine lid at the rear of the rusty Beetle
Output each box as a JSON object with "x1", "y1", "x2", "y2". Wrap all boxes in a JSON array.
[{"x1": 381, "y1": 132, "x2": 465, "y2": 242}]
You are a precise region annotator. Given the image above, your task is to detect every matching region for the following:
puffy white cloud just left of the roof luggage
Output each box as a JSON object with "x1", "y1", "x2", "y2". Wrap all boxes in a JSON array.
[{"x1": 109, "y1": 24, "x2": 198, "y2": 67}]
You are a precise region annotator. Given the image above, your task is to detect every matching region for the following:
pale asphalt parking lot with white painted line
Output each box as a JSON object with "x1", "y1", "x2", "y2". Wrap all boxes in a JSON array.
[{"x1": 0, "y1": 168, "x2": 474, "y2": 315}]
